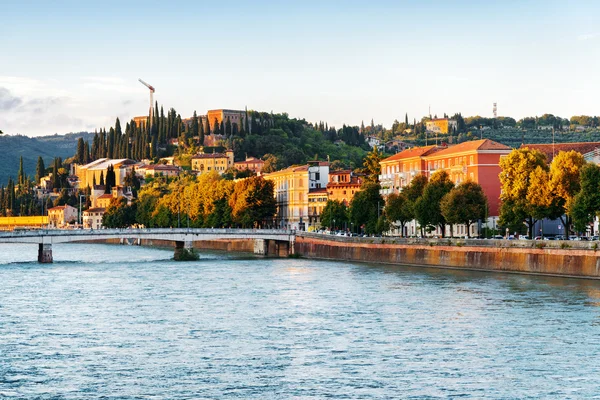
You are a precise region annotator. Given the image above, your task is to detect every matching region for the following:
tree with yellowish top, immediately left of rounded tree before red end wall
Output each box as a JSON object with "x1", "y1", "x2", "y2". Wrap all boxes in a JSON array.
[{"x1": 414, "y1": 170, "x2": 454, "y2": 237}]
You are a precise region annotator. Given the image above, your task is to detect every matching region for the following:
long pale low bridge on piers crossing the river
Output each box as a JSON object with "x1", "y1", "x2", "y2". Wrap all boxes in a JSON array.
[{"x1": 0, "y1": 228, "x2": 296, "y2": 263}]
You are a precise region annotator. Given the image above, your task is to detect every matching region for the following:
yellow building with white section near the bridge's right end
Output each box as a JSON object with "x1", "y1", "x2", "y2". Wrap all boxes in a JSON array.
[{"x1": 263, "y1": 161, "x2": 329, "y2": 230}]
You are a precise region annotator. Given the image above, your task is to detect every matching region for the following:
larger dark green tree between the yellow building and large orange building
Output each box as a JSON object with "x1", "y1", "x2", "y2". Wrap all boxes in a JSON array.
[{"x1": 348, "y1": 182, "x2": 385, "y2": 234}]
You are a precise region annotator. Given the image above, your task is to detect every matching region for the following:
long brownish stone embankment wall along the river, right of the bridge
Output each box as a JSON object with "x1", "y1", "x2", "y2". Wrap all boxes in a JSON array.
[{"x1": 295, "y1": 233, "x2": 600, "y2": 279}]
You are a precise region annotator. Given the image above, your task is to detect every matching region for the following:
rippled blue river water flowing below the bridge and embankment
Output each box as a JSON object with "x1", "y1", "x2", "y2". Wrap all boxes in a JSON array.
[{"x1": 0, "y1": 244, "x2": 600, "y2": 399}]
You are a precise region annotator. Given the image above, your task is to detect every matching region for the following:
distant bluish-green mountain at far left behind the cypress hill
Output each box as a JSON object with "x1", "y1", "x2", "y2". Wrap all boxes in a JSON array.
[{"x1": 0, "y1": 132, "x2": 94, "y2": 186}]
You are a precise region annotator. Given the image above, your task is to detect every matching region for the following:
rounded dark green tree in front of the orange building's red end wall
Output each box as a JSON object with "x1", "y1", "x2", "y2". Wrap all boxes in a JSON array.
[{"x1": 440, "y1": 181, "x2": 487, "y2": 236}]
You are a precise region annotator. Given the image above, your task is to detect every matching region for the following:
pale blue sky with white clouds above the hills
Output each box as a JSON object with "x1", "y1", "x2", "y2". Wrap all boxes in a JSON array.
[{"x1": 0, "y1": 0, "x2": 600, "y2": 136}]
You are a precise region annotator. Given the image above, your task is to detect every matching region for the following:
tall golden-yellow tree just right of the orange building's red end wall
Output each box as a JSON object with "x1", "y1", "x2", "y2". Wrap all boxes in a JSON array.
[{"x1": 498, "y1": 148, "x2": 548, "y2": 237}]
